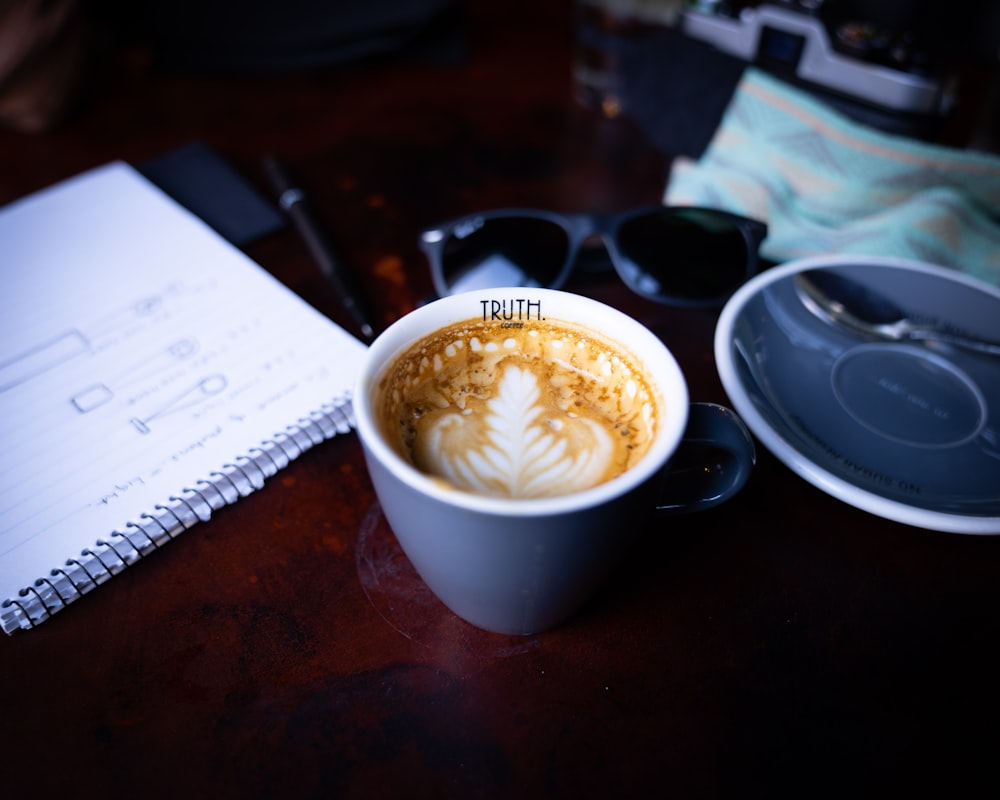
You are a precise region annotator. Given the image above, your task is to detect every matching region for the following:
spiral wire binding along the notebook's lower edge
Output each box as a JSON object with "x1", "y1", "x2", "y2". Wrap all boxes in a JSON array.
[{"x1": 0, "y1": 396, "x2": 354, "y2": 633}]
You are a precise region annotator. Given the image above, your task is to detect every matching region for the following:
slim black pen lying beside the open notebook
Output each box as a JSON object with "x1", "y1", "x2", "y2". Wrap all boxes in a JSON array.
[{"x1": 264, "y1": 156, "x2": 375, "y2": 341}]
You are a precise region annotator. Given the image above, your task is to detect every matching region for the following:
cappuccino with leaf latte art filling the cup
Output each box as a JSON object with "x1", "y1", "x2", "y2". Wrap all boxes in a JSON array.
[{"x1": 376, "y1": 315, "x2": 663, "y2": 498}]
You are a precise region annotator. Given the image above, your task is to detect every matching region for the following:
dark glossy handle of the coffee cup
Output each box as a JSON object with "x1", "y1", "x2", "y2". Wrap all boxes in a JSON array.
[{"x1": 656, "y1": 403, "x2": 757, "y2": 515}]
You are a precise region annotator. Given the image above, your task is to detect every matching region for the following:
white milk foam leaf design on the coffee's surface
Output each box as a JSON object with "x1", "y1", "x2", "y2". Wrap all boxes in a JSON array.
[{"x1": 418, "y1": 366, "x2": 613, "y2": 498}]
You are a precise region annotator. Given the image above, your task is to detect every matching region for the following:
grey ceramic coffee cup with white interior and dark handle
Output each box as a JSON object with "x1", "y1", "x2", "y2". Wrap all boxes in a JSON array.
[{"x1": 353, "y1": 287, "x2": 754, "y2": 634}]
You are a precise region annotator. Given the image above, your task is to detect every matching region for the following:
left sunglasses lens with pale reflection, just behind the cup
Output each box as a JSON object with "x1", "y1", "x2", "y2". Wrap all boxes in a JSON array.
[{"x1": 440, "y1": 216, "x2": 569, "y2": 293}]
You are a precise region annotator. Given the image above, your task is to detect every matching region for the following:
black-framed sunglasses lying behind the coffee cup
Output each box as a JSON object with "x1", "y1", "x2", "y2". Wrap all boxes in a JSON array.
[{"x1": 420, "y1": 206, "x2": 767, "y2": 308}]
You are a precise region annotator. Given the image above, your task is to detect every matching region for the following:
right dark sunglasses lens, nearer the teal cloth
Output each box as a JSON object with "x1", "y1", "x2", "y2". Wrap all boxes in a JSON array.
[{"x1": 617, "y1": 208, "x2": 751, "y2": 305}]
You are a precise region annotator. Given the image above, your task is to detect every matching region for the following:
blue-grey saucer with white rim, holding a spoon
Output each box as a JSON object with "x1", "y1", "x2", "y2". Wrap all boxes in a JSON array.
[{"x1": 715, "y1": 256, "x2": 1000, "y2": 534}]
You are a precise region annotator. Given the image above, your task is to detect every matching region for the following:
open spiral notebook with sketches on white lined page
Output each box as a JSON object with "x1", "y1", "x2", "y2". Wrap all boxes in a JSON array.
[{"x1": 0, "y1": 163, "x2": 365, "y2": 633}]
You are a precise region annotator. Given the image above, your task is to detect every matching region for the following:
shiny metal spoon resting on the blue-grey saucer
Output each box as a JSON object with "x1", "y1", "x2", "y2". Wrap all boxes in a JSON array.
[{"x1": 795, "y1": 269, "x2": 1000, "y2": 355}]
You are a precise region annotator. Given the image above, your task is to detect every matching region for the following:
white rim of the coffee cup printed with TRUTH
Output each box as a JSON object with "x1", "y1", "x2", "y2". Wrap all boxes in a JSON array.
[{"x1": 353, "y1": 287, "x2": 690, "y2": 517}]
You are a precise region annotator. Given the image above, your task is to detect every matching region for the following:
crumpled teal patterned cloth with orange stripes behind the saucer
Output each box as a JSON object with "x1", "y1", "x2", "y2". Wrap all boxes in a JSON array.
[{"x1": 664, "y1": 68, "x2": 1000, "y2": 285}]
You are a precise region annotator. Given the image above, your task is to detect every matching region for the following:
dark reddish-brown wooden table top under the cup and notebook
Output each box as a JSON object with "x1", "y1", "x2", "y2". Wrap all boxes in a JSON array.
[{"x1": 0, "y1": 1, "x2": 1000, "y2": 800}]
